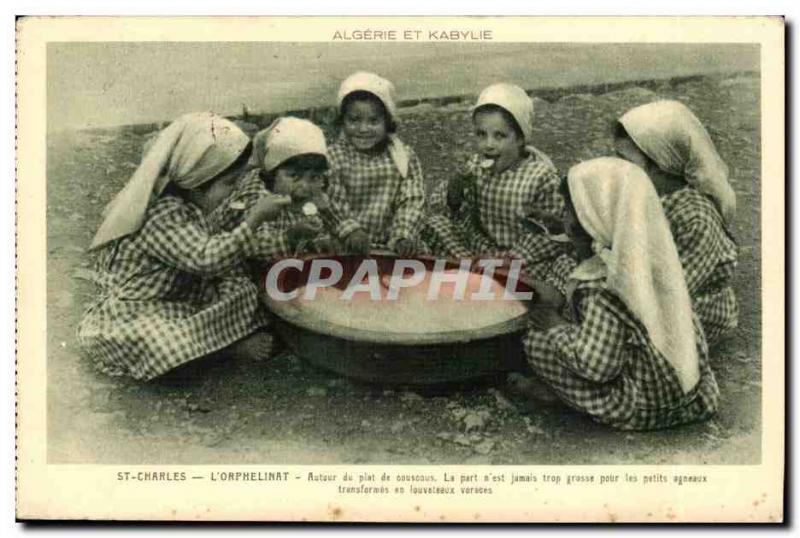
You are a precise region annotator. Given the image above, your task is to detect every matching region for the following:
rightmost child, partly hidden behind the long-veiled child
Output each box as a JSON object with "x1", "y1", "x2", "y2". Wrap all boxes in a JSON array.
[{"x1": 614, "y1": 101, "x2": 738, "y2": 343}]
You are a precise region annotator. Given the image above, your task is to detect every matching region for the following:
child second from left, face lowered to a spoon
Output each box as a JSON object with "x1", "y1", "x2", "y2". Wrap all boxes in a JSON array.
[{"x1": 224, "y1": 117, "x2": 339, "y2": 255}]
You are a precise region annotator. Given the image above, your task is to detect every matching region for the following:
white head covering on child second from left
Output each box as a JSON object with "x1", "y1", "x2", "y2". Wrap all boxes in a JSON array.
[{"x1": 250, "y1": 117, "x2": 328, "y2": 172}]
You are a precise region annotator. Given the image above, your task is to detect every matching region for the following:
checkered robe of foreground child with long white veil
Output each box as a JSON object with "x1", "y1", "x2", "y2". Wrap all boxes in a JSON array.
[{"x1": 524, "y1": 279, "x2": 719, "y2": 430}]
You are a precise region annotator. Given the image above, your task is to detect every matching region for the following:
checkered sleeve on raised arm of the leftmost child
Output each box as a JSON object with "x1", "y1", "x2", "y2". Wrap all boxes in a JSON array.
[{"x1": 140, "y1": 198, "x2": 253, "y2": 275}]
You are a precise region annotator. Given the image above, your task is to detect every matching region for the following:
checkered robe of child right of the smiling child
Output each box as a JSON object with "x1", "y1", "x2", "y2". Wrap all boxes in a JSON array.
[{"x1": 425, "y1": 148, "x2": 564, "y2": 278}]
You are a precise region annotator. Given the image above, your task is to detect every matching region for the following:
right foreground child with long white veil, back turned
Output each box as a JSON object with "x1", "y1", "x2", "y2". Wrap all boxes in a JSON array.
[{"x1": 524, "y1": 157, "x2": 719, "y2": 430}]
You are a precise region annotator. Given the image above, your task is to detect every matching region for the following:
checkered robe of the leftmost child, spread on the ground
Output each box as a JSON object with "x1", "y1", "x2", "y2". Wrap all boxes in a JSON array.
[{"x1": 78, "y1": 191, "x2": 268, "y2": 380}]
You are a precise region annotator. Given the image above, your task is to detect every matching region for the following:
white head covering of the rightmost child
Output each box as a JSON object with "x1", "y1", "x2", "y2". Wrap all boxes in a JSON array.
[{"x1": 619, "y1": 101, "x2": 736, "y2": 222}]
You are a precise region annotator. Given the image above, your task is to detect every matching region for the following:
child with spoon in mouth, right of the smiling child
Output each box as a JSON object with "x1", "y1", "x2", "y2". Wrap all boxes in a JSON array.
[{"x1": 426, "y1": 84, "x2": 563, "y2": 278}]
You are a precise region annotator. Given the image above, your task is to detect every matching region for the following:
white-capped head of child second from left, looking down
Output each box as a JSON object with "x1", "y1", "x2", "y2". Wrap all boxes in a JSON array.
[{"x1": 253, "y1": 117, "x2": 328, "y2": 204}]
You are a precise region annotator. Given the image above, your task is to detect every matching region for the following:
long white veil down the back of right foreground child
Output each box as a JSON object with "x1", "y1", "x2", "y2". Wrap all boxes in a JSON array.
[{"x1": 567, "y1": 157, "x2": 700, "y2": 392}]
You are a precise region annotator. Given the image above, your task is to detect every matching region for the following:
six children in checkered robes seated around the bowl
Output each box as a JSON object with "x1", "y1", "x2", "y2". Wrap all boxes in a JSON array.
[{"x1": 78, "y1": 72, "x2": 737, "y2": 429}]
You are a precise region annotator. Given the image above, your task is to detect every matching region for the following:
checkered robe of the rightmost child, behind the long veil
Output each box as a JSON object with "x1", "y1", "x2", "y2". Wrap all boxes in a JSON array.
[{"x1": 661, "y1": 187, "x2": 739, "y2": 343}]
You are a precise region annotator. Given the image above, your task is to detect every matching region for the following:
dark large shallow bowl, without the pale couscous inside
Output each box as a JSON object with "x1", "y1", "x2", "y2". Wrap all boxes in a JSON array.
[{"x1": 260, "y1": 253, "x2": 531, "y2": 384}]
